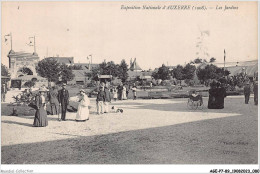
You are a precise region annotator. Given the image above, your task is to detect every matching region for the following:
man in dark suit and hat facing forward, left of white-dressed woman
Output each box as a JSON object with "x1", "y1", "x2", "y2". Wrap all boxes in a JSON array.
[{"x1": 58, "y1": 83, "x2": 69, "y2": 121}]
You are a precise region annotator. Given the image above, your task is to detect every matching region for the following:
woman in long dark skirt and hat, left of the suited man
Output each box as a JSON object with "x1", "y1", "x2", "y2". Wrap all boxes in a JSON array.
[{"x1": 33, "y1": 88, "x2": 48, "y2": 127}]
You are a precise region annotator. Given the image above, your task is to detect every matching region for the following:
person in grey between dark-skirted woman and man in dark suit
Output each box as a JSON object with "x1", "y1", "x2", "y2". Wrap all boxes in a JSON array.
[{"x1": 49, "y1": 86, "x2": 59, "y2": 115}]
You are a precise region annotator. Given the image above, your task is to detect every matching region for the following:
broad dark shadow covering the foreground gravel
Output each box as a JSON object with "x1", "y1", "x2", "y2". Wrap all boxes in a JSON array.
[{"x1": 2, "y1": 113, "x2": 258, "y2": 164}]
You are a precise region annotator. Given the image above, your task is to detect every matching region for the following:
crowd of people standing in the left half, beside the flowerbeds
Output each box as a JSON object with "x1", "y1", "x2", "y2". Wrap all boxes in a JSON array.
[{"x1": 29, "y1": 83, "x2": 137, "y2": 127}]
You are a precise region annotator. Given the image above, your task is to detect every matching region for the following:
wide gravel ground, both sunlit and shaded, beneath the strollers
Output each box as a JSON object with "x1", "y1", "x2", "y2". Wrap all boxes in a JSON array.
[{"x1": 2, "y1": 96, "x2": 258, "y2": 164}]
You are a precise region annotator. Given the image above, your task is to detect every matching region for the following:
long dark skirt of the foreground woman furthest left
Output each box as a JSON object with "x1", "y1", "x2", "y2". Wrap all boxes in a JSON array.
[{"x1": 33, "y1": 107, "x2": 48, "y2": 127}]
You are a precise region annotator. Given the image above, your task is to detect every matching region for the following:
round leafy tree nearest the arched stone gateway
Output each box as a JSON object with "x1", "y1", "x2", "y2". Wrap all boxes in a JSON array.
[{"x1": 36, "y1": 59, "x2": 60, "y2": 82}]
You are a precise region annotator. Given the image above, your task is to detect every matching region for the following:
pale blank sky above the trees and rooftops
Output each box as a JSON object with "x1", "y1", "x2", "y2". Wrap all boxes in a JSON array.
[{"x1": 1, "y1": 2, "x2": 258, "y2": 69}]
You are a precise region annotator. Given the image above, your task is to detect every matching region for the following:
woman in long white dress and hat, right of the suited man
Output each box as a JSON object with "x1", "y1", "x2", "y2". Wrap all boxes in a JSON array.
[{"x1": 76, "y1": 90, "x2": 90, "y2": 121}]
